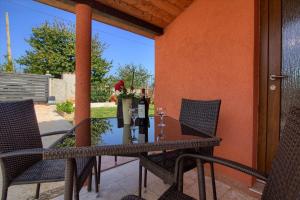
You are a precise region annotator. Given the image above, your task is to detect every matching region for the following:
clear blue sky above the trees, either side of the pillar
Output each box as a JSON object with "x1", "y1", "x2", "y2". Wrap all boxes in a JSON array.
[{"x1": 0, "y1": 0, "x2": 154, "y2": 74}]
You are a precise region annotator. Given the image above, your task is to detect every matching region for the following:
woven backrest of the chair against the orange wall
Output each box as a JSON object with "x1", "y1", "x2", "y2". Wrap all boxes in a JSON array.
[{"x1": 179, "y1": 99, "x2": 221, "y2": 136}]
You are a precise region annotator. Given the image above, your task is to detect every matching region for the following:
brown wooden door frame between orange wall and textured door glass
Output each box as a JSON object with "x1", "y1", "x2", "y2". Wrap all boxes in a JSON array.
[{"x1": 257, "y1": 0, "x2": 282, "y2": 173}]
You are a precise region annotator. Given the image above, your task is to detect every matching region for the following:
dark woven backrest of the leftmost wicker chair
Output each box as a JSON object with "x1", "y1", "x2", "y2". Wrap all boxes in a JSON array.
[{"x1": 0, "y1": 100, "x2": 43, "y2": 181}]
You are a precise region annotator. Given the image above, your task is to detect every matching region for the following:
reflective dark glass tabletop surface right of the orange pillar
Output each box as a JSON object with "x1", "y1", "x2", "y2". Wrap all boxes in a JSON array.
[{"x1": 72, "y1": 116, "x2": 217, "y2": 146}]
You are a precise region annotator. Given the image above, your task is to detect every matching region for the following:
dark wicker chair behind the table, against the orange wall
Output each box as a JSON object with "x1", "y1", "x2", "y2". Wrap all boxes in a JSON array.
[{"x1": 139, "y1": 99, "x2": 221, "y2": 198}]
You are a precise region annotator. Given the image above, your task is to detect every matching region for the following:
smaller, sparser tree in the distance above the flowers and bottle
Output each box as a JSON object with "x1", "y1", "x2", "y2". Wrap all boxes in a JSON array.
[{"x1": 111, "y1": 64, "x2": 152, "y2": 88}]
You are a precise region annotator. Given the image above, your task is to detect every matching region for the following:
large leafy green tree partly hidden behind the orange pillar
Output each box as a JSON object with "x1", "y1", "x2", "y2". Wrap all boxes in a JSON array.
[{"x1": 17, "y1": 21, "x2": 111, "y2": 78}]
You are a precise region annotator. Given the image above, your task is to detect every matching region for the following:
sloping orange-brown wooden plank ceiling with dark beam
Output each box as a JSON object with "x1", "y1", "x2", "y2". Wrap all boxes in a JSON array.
[{"x1": 36, "y1": 0, "x2": 194, "y2": 38}]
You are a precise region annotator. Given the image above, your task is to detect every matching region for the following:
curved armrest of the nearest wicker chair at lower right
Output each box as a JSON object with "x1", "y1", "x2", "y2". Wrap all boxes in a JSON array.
[{"x1": 175, "y1": 154, "x2": 268, "y2": 181}]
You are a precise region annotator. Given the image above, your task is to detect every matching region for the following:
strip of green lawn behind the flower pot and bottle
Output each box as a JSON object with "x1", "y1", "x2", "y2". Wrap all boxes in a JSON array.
[{"x1": 91, "y1": 104, "x2": 154, "y2": 118}]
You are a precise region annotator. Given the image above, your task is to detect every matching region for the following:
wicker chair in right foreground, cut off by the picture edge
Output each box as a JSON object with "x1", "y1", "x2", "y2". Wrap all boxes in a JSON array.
[{"x1": 122, "y1": 107, "x2": 300, "y2": 200}]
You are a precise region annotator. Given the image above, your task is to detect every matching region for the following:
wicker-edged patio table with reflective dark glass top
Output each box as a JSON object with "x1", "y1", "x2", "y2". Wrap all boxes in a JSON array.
[{"x1": 6, "y1": 116, "x2": 221, "y2": 200}]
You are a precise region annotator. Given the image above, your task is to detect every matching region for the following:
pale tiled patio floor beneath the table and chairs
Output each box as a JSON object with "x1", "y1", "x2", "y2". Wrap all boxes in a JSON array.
[{"x1": 55, "y1": 161, "x2": 258, "y2": 200}]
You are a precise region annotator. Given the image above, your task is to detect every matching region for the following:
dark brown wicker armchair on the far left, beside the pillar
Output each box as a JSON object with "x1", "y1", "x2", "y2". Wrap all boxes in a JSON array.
[{"x1": 0, "y1": 100, "x2": 98, "y2": 200}]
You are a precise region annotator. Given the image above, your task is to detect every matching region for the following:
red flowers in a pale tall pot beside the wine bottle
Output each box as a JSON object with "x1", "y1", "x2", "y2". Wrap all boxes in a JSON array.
[{"x1": 115, "y1": 80, "x2": 135, "y2": 124}]
